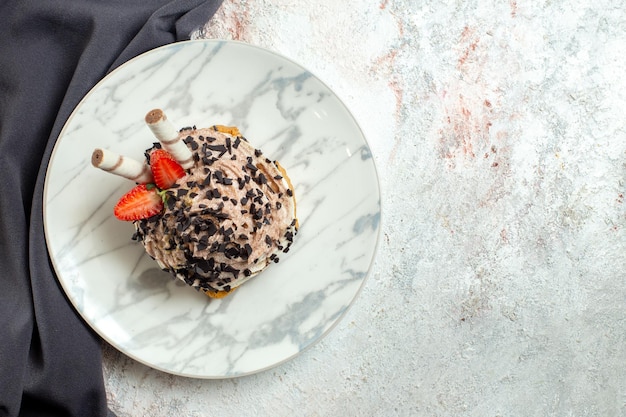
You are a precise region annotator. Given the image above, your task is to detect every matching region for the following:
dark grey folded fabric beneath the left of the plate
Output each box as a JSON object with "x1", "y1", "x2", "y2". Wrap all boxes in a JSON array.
[{"x1": 0, "y1": 0, "x2": 221, "y2": 417}]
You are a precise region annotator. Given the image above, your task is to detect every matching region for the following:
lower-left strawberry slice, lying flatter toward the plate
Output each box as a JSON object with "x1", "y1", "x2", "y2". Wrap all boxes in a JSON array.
[{"x1": 113, "y1": 184, "x2": 163, "y2": 221}]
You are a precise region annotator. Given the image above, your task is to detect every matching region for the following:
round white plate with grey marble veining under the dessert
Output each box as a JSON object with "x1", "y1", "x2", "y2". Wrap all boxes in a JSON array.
[{"x1": 44, "y1": 40, "x2": 381, "y2": 378}]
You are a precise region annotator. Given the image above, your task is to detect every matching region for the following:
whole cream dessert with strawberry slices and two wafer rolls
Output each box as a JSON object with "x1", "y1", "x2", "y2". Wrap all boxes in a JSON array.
[{"x1": 92, "y1": 109, "x2": 298, "y2": 298}]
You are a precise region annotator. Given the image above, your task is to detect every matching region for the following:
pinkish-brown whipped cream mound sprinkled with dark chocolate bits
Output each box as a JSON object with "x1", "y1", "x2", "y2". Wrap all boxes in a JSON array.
[{"x1": 133, "y1": 126, "x2": 298, "y2": 293}]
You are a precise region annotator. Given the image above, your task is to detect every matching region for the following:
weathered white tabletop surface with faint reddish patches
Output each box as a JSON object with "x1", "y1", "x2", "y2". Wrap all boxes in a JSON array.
[{"x1": 104, "y1": 0, "x2": 626, "y2": 417}]
